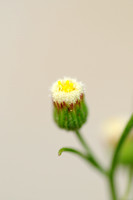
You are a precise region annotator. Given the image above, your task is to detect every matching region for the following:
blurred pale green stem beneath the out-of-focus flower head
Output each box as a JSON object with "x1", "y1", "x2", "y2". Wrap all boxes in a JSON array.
[{"x1": 122, "y1": 166, "x2": 133, "y2": 200}]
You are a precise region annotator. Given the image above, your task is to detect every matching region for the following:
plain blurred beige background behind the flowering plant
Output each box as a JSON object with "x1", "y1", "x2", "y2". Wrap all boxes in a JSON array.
[{"x1": 0, "y1": 0, "x2": 133, "y2": 200}]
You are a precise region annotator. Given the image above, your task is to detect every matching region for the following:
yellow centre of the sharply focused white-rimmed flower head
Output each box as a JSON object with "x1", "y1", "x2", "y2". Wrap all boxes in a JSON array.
[{"x1": 58, "y1": 80, "x2": 75, "y2": 92}]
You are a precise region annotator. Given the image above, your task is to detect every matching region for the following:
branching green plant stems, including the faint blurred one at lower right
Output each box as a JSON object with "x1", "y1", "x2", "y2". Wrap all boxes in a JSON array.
[{"x1": 58, "y1": 114, "x2": 133, "y2": 200}]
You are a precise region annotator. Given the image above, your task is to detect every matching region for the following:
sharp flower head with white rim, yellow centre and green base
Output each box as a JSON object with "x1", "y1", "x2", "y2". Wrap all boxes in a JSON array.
[{"x1": 51, "y1": 78, "x2": 88, "y2": 130}]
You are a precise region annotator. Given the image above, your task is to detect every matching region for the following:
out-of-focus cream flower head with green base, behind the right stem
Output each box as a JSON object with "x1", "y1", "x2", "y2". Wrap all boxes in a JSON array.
[{"x1": 103, "y1": 116, "x2": 133, "y2": 165}]
